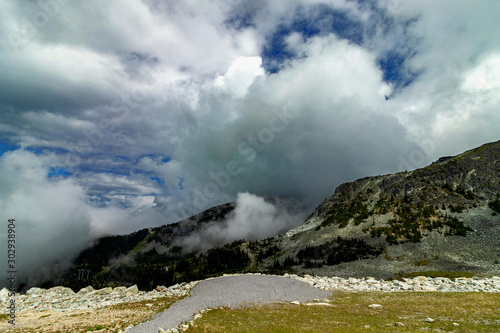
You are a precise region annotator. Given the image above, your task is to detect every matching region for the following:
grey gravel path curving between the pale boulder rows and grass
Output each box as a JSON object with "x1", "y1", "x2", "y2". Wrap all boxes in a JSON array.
[{"x1": 126, "y1": 275, "x2": 331, "y2": 333}]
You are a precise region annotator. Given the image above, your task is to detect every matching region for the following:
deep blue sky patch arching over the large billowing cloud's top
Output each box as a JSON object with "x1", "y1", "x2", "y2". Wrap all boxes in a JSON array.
[{"x1": 258, "y1": 0, "x2": 418, "y2": 92}]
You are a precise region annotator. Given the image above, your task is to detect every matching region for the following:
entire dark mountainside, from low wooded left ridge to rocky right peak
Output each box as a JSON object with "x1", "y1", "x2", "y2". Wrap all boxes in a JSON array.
[{"x1": 62, "y1": 141, "x2": 500, "y2": 290}]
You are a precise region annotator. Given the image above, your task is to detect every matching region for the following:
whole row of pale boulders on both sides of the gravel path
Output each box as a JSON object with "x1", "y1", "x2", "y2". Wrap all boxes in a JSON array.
[{"x1": 0, "y1": 274, "x2": 500, "y2": 312}]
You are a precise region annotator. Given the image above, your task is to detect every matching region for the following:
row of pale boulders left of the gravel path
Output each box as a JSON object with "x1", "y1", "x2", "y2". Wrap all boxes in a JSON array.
[{"x1": 0, "y1": 281, "x2": 199, "y2": 312}]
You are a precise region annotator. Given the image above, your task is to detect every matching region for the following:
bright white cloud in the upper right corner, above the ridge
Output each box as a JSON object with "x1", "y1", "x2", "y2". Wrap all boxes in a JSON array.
[{"x1": 378, "y1": 1, "x2": 500, "y2": 157}]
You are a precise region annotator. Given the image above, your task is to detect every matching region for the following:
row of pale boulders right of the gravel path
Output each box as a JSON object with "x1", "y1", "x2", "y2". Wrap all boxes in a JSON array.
[{"x1": 285, "y1": 274, "x2": 500, "y2": 293}]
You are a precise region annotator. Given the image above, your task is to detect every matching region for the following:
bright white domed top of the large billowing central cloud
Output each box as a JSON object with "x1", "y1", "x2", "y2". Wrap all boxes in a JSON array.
[{"x1": 273, "y1": 35, "x2": 391, "y2": 106}]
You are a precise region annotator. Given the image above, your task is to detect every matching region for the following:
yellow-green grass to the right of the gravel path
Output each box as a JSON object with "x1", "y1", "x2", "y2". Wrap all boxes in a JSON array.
[{"x1": 187, "y1": 291, "x2": 500, "y2": 333}]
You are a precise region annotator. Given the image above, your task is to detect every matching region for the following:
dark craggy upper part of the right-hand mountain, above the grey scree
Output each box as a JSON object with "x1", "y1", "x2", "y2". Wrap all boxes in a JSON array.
[{"x1": 300, "y1": 141, "x2": 500, "y2": 235}]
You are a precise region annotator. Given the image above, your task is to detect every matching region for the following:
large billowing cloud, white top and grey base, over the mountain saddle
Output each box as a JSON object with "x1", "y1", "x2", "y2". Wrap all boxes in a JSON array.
[{"x1": 179, "y1": 35, "x2": 411, "y2": 208}]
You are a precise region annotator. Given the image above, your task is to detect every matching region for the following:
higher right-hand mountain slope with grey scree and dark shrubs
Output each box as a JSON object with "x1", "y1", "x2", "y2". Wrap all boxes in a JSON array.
[{"x1": 267, "y1": 141, "x2": 500, "y2": 278}]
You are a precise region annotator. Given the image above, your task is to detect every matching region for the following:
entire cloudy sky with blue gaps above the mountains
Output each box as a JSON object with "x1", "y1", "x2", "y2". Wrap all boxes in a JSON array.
[{"x1": 0, "y1": 0, "x2": 500, "y2": 286}]
